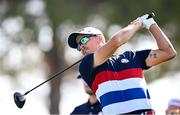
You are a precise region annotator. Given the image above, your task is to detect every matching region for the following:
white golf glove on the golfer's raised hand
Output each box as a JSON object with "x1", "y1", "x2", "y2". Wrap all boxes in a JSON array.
[{"x1": 139, "y1": 14, "x2": 156, "y2": 29}]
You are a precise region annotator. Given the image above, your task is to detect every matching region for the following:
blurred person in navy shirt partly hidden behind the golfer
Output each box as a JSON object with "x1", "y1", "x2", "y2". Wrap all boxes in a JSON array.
[{"x1": 71, "y1": 75, "x2": 102, "y2": 115}]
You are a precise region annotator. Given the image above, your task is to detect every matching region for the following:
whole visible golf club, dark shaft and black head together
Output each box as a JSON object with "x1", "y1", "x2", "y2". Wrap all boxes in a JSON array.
[{"x1": 14, "y1": 59, "x2": 82, "y2": 108}]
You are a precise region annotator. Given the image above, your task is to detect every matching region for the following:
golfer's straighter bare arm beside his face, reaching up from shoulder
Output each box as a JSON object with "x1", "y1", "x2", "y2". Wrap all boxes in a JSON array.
[{"x1": 94, "y1": 22, "x2": 142, "y2": 67}]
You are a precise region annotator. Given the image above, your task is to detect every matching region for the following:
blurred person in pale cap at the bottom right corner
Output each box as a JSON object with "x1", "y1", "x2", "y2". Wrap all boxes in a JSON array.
[{"x1": 166, "y1": 98, "x2": 180, "y2": 115}]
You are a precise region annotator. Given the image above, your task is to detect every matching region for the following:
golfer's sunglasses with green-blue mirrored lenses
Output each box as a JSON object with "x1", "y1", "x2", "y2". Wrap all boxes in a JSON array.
[{"x1": 77, "y1": 35, "x2": 97, "y2": 51}]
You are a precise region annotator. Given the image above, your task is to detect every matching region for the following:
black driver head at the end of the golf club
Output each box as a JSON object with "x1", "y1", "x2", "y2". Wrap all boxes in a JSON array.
[{"x1": 14, "y1": 92, "x2": 26, "y2": 108}]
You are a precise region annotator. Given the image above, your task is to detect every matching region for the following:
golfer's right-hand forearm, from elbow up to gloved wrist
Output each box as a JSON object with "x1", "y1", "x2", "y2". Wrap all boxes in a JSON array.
[{"x1": 150, "y1": 24, "x2": 176, "y2": 57}]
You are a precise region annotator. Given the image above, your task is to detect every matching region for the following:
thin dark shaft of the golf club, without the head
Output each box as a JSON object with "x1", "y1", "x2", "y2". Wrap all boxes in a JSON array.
[{"x1": 24, "y1": 59, "x2": 82, "y2": 95}]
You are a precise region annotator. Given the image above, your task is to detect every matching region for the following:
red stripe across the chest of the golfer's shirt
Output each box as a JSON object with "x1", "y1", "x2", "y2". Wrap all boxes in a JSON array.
[{"x1": 91, "y1": 68, "x2": 143, "y2": 93}]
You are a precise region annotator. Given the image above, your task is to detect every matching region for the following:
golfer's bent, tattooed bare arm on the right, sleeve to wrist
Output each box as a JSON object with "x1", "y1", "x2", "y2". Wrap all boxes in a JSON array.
[{"x1": 146, "y1": 24, "x2": 176, "y2": 67}]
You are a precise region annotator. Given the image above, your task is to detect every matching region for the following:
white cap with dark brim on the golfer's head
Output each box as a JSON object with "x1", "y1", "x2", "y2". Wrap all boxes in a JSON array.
[{"x1": 68, "y1": 27, "x2": 103, "y2": 48}]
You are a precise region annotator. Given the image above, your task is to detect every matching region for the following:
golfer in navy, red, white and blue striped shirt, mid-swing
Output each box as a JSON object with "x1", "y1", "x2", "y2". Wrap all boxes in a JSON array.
[{"x1": 68, "y1": 14, "x2": 176, "y2": 115}]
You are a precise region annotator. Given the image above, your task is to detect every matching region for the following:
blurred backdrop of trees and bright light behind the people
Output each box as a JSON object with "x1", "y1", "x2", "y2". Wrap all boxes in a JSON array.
[{"x1": 0, "y1": 0, "x2": 180, "y2": 115}]
